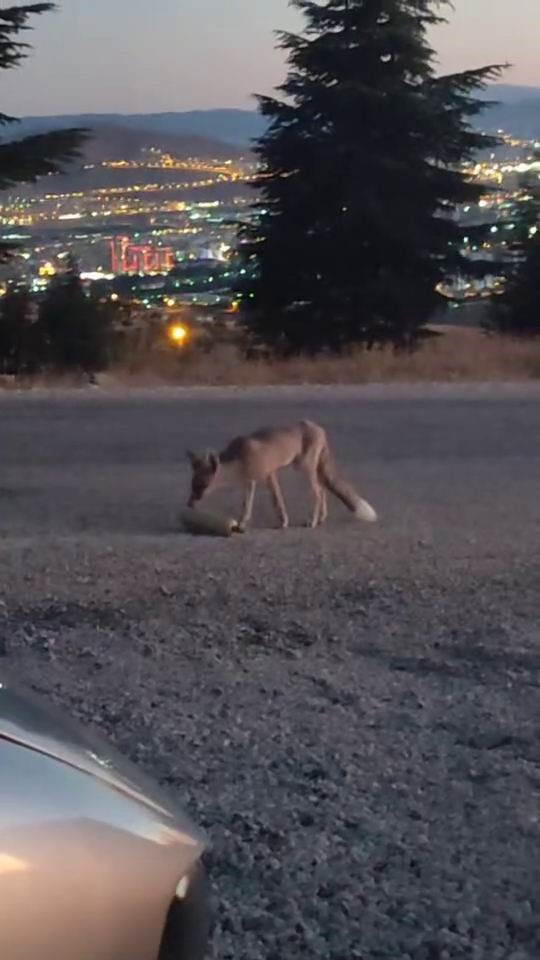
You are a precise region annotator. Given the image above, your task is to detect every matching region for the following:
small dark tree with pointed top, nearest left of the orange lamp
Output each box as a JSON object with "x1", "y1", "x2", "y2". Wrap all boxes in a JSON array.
[{"x1": 38, "y1": 260, "x2": 111, "y2": 373}]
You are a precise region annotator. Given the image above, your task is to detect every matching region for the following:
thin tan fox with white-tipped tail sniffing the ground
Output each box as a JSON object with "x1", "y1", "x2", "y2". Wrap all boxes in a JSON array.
[{"x1": 188, "y1": 420, "x2": 377, "y2": 528}]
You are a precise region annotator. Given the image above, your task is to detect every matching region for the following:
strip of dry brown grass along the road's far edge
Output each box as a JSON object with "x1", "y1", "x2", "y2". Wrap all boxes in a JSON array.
[{"x1": 4, "y1": 327, "x2": 540, "y2": 389}]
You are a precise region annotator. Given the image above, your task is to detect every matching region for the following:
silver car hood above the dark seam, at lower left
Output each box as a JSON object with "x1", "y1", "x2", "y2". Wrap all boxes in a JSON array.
[{"x1": 0, "y1": 678, "x2": 206, "y2": 847}]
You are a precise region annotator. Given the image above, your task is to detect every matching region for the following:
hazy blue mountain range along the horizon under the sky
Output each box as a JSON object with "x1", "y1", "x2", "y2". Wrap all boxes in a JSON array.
[{"x1": 10, "y1": 84, "x2": 540, "y2": 159}]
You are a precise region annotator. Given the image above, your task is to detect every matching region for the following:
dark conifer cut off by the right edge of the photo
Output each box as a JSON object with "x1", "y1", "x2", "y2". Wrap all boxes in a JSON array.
[{"x1": 488, "y1": 152, "x2": 540, "y2": 337}]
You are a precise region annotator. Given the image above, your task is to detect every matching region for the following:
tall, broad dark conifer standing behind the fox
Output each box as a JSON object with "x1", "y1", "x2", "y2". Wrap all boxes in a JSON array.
[{"x1": 240, "y1": 0, "x2": 503, "y2": 354}]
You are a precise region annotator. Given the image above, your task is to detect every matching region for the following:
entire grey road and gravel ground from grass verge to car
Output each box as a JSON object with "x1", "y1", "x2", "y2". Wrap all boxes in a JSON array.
[{"x1": 0, "y1": 388, "x2": 540, "y2": 960}]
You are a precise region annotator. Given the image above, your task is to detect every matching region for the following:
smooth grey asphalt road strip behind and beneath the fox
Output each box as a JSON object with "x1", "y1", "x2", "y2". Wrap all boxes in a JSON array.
[{"x1": 0, "y1": 390, "x2": 540, "y2": 548}]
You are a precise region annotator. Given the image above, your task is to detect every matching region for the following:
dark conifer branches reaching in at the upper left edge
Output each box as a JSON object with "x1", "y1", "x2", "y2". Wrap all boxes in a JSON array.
[{"x1": 0, "y1": 3, "x2": 86, "y2": 262}]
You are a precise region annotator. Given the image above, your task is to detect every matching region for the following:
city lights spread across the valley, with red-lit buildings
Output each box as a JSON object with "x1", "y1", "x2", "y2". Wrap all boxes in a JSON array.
[{"x1": 0, "y1": 125, "x2": 540, "y2": 309}]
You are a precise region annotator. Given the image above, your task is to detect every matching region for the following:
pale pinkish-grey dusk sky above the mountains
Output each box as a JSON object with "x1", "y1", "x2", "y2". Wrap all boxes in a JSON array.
[{"x1": 4, "y1": 0, "x2": 540, "y2": 116}]
